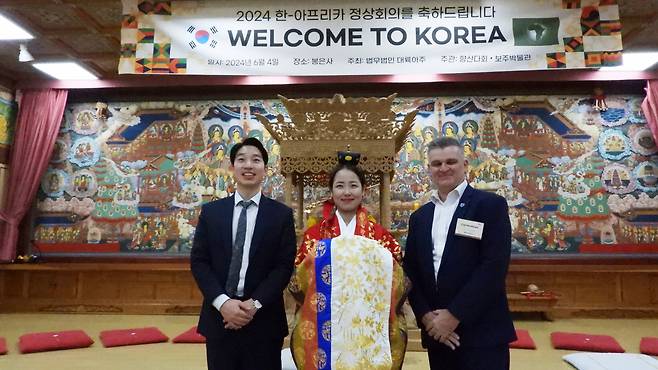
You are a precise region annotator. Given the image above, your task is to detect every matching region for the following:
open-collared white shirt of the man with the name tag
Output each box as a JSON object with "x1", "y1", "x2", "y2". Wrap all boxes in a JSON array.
[{"x1": 430, "y1": 180, "x2": 468, "y2": 278}]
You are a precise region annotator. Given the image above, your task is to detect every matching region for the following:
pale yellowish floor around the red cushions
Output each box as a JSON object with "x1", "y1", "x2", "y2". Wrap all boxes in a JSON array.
[{"x1": 0, "y1": 314, "x2": 658, "y2": 370}]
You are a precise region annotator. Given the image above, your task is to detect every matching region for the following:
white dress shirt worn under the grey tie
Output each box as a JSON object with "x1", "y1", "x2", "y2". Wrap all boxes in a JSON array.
[{"x1": 212, "y1": 191, "x2": 261, "y2": 310}]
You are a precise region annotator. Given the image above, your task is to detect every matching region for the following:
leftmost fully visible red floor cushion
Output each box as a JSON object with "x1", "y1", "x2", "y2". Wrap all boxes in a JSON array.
[{"x1": 18, "y1": 330, "x2": 94, "y2": 353}]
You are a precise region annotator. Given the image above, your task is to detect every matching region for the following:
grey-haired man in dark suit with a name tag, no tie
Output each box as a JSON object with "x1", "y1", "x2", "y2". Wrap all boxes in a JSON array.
[{"x1": 404, "y1": 137, "x2": 516, "y2": 370}]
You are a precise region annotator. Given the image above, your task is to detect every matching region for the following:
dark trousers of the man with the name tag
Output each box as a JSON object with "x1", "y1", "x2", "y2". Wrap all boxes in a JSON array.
[{"x1": 427, "y1": 345, "x2": 509, "y2": 370}]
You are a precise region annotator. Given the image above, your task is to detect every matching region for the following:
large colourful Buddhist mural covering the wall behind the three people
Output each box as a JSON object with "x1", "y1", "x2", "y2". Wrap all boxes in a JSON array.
[{"x1": 34, "y1": 96, "x2": 658, "y2": 256}]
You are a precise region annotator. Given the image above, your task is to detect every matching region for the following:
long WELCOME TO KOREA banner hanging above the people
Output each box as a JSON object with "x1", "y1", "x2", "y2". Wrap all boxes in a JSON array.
[{"x1": 119, "y1": 0, "x2": 622, "y2": 76}]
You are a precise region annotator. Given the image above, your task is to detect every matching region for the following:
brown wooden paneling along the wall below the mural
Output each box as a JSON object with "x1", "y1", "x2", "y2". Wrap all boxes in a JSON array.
[{"x1": 0, "y1": 262, "x2": 658, "y2": 318}]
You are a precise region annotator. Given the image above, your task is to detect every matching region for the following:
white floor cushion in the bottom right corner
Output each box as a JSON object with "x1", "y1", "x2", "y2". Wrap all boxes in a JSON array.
[{"x1": 562, "y1": 352, "x2": 658, "y2": 370}]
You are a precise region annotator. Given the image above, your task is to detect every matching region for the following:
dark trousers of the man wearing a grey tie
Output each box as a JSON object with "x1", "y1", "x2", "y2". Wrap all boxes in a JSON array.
[{"x1": 206, "y1": 330, "x2": 283, "y2": 370}]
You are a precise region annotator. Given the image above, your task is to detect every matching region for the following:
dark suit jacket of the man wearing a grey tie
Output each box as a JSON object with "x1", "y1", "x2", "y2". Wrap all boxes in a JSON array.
[{"x1": 190, "y1": 196, "x2": 296, "y2": 339}]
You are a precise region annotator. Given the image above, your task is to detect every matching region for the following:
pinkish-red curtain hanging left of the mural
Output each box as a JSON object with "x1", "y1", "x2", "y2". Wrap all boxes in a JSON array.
[{"x1": 0, "y1": 89, "x2": 68, "y2": 262}]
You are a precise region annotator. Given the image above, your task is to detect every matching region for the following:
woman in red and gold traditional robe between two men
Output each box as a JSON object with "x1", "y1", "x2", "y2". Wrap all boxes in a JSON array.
[{"x1": 289, "y1": 152, "x2": 407, "y2": 369}]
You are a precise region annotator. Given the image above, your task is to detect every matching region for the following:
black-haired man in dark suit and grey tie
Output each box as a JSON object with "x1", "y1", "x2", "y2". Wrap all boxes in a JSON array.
[{"x1": 190, "y1": 138, "x2": 296, "y2": 370}]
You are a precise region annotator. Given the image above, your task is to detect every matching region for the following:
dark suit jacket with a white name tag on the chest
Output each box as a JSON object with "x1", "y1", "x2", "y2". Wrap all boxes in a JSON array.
[{"x1": 404, "y1": 186, "x2": 516, "y2": 348}]
